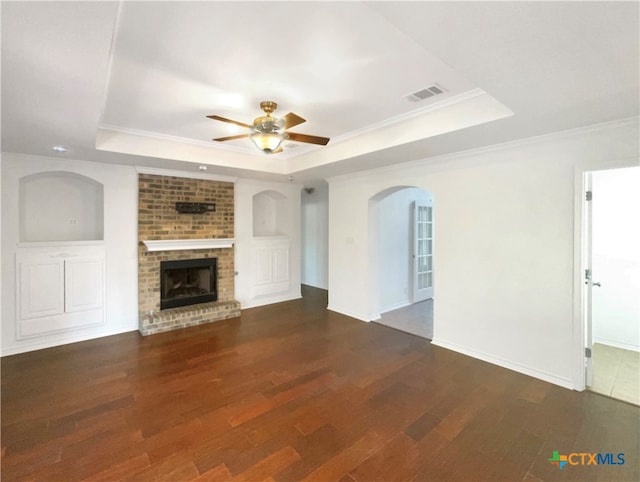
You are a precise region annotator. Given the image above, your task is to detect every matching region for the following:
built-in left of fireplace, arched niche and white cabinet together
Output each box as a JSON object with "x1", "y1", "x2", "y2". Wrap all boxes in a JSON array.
[{"x1": 15, "y1": 171, "x2": 105, "y2": 339}]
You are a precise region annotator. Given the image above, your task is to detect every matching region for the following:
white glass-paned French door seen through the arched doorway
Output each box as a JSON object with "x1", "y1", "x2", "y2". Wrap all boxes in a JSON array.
[{"x1": 413, "y1": 202, "x2": 433, "y2": 303}]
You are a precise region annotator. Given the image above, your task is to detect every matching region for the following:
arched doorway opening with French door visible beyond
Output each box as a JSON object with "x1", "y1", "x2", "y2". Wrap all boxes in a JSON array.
[{"x1": 369, "y1": 186, "x2": 435, "y2": 339}]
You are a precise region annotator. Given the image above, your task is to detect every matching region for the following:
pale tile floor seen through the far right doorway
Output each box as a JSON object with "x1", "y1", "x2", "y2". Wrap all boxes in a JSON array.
[{"x1": 591, "y1": 343, "x2": 640, "y2": 405}]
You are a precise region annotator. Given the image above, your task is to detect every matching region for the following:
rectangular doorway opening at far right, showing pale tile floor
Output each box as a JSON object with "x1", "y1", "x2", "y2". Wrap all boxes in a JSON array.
[{"x1": 583, "y1": 167, "x2": 640, "y2": 405}]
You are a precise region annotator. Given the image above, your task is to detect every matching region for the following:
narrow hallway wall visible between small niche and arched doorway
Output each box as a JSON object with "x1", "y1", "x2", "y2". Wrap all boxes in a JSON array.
[{"x1": 301, "y1": 183, "x2": 329, "y2": 290}]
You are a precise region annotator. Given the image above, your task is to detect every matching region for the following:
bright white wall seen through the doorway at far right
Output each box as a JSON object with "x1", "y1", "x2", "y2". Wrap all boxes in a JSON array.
[{"x1": 592, "y1": 167, "x2": 640, "y2": 351}]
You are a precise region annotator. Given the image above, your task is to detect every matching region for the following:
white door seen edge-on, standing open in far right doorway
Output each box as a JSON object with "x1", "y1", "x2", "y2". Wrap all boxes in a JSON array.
[{"x1": 582, "y1": 173, "x2": 593, "y2": 387}]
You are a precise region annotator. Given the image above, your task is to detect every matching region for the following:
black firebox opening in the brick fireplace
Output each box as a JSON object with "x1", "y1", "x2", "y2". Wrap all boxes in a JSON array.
[{"x1": 160, "y1": 258, "x2": 218, "y2": 310}]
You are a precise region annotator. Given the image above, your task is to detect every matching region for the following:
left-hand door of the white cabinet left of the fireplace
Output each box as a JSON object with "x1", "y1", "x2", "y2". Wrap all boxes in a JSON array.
[{"x1": 18, "y1": 257, "x2": 64, "y2": 320}]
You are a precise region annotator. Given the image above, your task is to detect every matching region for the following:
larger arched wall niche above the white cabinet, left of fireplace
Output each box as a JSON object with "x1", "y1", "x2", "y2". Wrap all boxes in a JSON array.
[{"x1": 19, "y1": 171, "x2": 104, "y2": 242}]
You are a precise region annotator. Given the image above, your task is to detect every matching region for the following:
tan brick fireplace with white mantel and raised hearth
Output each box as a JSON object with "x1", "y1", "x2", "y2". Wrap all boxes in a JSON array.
[{"x1": 138, "y1": 174, "x2": 240, "y2": 335}]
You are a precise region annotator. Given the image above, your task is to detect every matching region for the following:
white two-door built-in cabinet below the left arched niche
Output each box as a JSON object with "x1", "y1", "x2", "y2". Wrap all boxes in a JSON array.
[{"x1": 16, "y1": 246, "x2": 105, "y2": 338}]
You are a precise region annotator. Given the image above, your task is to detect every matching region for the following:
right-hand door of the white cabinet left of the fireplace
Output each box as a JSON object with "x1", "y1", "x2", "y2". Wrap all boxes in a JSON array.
[{"x1": 64, "y1": 258, "x2": 104, "y2": 313}]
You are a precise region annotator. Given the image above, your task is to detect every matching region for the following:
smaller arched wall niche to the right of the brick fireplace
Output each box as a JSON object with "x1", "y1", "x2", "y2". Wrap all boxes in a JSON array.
[{"x1": 253, "y1": 191, "x2": 290, "y2": 237}]
